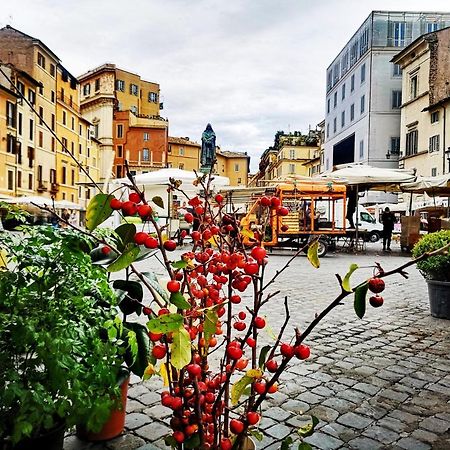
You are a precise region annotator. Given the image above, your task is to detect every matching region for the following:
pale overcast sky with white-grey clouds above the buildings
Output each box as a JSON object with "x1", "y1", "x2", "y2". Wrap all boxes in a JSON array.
[{"x1": 0, "y1": 0, "x2": 450, "y2": 170}]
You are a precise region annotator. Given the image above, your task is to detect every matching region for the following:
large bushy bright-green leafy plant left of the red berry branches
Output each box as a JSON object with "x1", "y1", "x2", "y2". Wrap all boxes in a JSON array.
[{"x1": 0, "y1": 227, "x2": 123, "y2": 450}]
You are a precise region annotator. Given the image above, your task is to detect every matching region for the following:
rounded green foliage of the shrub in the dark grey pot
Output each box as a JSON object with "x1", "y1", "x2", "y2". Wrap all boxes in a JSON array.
[{"x1": 412, "y1": 230, "x2": 450, "y2": 281}]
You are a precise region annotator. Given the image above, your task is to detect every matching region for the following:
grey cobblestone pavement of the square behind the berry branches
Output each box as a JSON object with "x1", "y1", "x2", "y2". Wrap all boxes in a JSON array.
[{"x1": 65, "y1": 243, "x2": 450, "y2": 450}]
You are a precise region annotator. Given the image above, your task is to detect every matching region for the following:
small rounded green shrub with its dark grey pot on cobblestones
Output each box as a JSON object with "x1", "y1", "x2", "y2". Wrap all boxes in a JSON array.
[{"x1": 412, "y1": 230, "x2": 450, "y2": 319}]
